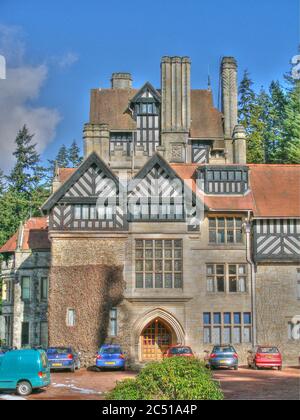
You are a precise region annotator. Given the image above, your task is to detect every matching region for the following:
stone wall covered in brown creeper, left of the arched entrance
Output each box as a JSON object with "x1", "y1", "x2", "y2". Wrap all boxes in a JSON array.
[{"x1": 49, "y1": 238, "x2": 125, "y2": 365}]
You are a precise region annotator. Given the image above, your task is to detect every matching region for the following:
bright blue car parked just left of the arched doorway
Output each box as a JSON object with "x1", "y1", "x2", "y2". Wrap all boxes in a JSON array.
[{"x1": 96, "y1": 345, "x2": 126, "y2": 370}]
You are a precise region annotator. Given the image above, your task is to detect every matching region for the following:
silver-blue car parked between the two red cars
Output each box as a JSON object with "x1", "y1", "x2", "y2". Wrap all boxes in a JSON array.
[{"x1": 206, "y1": 345, "x2": 239, "y2": 370}]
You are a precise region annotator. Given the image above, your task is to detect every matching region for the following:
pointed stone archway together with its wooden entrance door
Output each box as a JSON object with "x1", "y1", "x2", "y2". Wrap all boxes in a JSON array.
[{"x1": 134, "y1": 309, "x2": 185, "y2": 361}]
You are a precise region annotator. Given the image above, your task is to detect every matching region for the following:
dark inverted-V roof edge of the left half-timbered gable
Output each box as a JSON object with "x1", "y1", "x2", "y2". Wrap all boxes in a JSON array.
[{"x1": 42, "y1": 152, "x2": 119, "y2": 212}]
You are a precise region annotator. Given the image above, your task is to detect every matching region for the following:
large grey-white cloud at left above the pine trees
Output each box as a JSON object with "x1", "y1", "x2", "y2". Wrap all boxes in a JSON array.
[{"x1": 0, "y1": 25, "x2": 61, "y2": 172}]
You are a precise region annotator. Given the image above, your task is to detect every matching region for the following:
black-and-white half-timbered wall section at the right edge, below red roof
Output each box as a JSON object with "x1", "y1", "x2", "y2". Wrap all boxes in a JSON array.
[{"x1": 253, "y1": 219, "x2": 300, "y2": 262}]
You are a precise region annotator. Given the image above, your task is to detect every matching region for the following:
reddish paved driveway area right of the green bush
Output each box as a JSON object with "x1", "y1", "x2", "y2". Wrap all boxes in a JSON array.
[{"x1": 214, "y1": 369, "x2": 300, "y2": 401}]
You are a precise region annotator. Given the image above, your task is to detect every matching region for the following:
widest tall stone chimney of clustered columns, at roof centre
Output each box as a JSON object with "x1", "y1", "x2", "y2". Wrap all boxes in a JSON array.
[{"x1": 161, "y1": 57, "x2": 191, "y2": 162}]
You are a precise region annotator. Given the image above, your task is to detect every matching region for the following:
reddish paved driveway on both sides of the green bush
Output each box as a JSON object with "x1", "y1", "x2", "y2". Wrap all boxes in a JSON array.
[{"x1": 0, "y1": 369, "x2": 300, "y2": 400}]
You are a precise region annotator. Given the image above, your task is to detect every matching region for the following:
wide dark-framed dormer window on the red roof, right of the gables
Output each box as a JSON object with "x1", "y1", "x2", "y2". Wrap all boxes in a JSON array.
[{"x1": 198, "y1": 166, "x2": 249, "y2": 195}]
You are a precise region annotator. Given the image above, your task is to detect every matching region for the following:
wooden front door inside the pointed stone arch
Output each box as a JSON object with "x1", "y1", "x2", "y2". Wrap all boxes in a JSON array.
[{"x1": 141, "y1": 320, "x2": 172, "y2": 361}]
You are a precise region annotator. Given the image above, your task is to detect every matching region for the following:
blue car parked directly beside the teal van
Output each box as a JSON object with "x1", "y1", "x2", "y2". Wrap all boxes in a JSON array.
[{"x1": 47, "y1": 347, "x2": 80, "y2": 373}]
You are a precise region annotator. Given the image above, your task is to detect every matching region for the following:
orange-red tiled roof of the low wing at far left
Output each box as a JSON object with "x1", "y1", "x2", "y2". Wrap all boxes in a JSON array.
[{"x1": 0, "y1": 217, "x2": 51, "y2": 254}]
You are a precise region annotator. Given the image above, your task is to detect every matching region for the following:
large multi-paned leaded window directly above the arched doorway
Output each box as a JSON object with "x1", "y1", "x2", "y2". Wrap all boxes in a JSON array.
[{"x1": 135, "y1": 239, "x2": 183, "y2": 289}]
